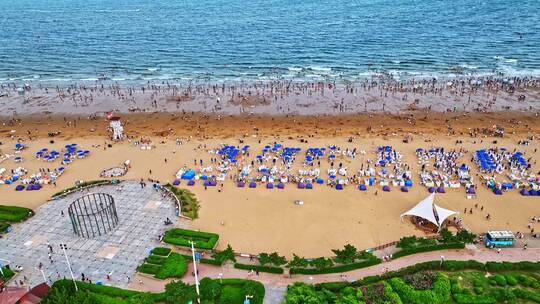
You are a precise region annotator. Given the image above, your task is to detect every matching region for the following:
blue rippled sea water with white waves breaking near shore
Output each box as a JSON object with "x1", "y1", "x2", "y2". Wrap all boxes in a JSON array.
[{"x1": 0, "y1": 0, "x2": 540, "y2": 83}]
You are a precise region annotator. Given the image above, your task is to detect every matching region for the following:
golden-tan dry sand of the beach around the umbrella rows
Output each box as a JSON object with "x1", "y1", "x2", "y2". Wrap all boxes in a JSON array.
[{"x1": 0, "y1": 111, "x2": 540, "y2": 257}]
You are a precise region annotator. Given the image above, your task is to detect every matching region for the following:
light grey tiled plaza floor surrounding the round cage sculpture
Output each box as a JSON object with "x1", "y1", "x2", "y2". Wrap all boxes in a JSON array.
[{"x1": 0, "y1": 181, "x2": 178, "y2": 287}]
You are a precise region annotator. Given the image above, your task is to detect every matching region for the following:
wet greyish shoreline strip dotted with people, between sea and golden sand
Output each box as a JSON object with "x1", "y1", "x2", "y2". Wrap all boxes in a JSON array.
[{"x1": 0, "y1": 77, "x2": 540, "y2": 115}]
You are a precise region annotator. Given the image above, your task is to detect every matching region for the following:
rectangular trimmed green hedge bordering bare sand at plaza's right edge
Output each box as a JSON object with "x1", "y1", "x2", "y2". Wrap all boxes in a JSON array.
[{"x1": 163, "y1": 228, "x2": 219, "y2": 250}]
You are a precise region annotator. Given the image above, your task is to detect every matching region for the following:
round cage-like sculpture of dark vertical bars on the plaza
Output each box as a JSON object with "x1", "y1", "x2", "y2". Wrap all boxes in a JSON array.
[{"x1": 68, "y1": 193, "x2": 118, "y2": 238}]
